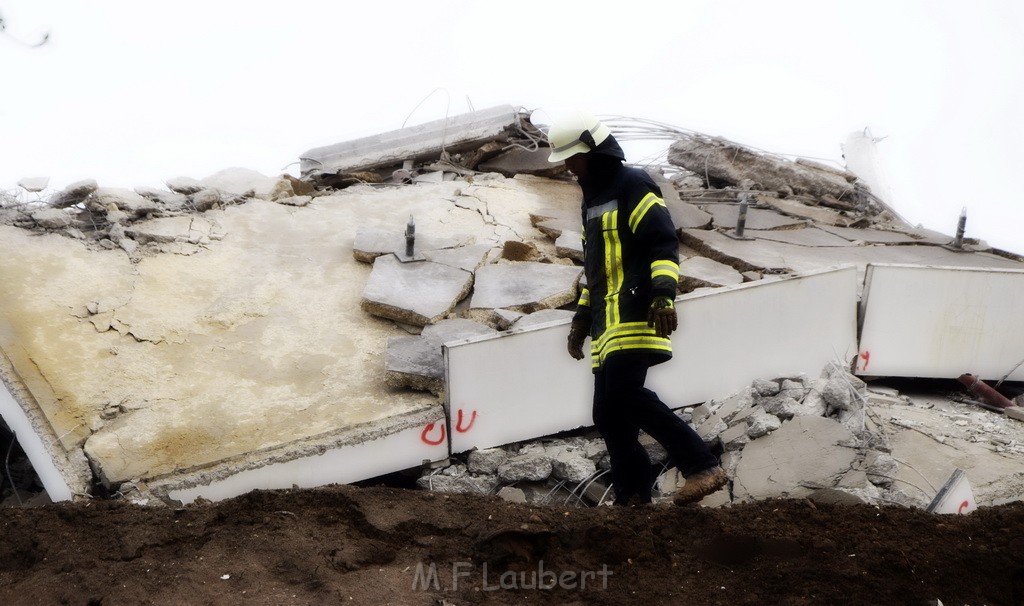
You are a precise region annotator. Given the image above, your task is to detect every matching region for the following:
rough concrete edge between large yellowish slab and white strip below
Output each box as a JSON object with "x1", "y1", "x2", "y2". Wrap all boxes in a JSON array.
[{"x1": 144, "y1": 402, "x2": 447, "y2": 504}]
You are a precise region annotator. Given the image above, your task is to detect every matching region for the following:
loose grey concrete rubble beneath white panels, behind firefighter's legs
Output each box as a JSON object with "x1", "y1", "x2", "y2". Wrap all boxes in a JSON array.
[{"x1": 417, "y1": 363, "x2": 1024, "y2": 509}]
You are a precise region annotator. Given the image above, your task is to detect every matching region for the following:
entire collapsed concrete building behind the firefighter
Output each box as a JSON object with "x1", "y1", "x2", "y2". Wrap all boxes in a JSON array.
[{"x1": 0, "y1": 106, "x2": 1024, "y2": 507}]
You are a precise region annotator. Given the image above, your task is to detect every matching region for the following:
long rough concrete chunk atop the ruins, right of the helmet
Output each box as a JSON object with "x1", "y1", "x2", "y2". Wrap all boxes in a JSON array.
[{"x1": 669, "y1": 134, "x2": 854, "y2": 200}]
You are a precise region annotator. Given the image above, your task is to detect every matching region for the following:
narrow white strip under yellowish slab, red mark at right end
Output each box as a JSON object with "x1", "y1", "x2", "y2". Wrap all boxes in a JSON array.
[{"x1": 167, "y1": 420, "x2": 449, "y2": 504}]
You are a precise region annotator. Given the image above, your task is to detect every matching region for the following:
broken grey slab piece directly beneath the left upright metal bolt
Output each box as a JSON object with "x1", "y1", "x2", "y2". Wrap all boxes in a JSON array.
[{"x1": 360, "y1": 255, "x2": 473, "y2": 327}]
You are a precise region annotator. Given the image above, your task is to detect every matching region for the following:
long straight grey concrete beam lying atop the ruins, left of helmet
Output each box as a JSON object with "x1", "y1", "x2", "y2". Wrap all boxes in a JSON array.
[{"x1": 300, "y1": 105, "x2": 520, "y2": 177}]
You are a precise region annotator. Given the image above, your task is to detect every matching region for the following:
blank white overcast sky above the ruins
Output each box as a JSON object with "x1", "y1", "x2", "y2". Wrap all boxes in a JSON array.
[{"x1": 0, "y1": 0, "x2": 1024, "y2": 253}]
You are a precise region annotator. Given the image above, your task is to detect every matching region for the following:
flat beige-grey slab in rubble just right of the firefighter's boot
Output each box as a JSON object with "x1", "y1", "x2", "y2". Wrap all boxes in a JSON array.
[{"x1": 732, "y1": 417, "x2": 857, "y2": 503}]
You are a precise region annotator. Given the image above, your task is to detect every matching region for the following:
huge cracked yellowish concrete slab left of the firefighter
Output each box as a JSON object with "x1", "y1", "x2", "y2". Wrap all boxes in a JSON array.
[{"x1": 0, "y1": 174, "x2": 561, "y2": 496}]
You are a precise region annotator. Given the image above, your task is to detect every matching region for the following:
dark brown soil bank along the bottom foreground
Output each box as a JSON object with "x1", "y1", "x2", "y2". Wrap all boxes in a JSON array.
[{"x1": 0, "y1": 486, "x2": 1024, "y2": 606}]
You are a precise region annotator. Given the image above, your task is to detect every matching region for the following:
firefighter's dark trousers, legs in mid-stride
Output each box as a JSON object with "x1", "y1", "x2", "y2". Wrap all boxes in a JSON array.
[{"x1": 594, "y1": 353, "x2": 718, "y2": 503}]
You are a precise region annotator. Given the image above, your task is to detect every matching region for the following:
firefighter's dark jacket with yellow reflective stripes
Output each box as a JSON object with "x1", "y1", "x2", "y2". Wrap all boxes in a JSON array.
[{"x1": 573, "y1": 161, "x2": 679, "y2": 371}]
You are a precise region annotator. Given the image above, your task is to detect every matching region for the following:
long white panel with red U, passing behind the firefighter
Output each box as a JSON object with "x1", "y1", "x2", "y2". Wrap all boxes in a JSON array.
[{"x1": 444, "y1": 266, "x2": 857, "y2": 452}]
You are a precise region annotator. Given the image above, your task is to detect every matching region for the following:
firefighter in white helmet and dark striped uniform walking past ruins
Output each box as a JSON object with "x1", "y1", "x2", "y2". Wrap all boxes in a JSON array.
[{"x1": 548, "y1": 114, "x2": 727, "y2": 505}]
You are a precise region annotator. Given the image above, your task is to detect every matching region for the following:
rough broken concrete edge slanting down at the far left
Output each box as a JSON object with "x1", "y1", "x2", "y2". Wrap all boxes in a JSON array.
[{"x1": 0, "y1": 348, "x2": 92, "y2": 502}]
